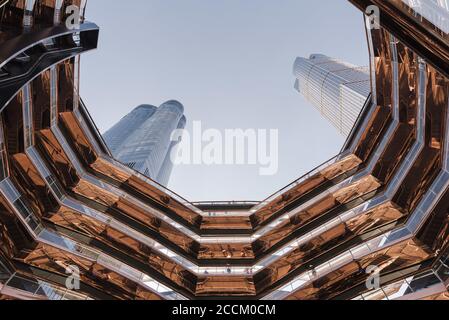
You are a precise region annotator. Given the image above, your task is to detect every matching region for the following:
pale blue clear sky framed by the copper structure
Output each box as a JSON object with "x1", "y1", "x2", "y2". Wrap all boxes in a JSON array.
[{"x1": 81, "y1": 0, "x2": 368, "y2": 201}]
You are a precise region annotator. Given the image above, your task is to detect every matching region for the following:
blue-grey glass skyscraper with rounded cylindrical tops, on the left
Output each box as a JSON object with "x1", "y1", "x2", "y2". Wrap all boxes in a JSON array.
[{"x1": 104, "y1": 100, "x2": 186, "y2": 186}]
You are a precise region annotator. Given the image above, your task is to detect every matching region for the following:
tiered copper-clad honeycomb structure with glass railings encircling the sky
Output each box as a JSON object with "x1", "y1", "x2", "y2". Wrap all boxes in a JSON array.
[{"x1": 0, "y1": 0, "x2": 449, "y2": 300}]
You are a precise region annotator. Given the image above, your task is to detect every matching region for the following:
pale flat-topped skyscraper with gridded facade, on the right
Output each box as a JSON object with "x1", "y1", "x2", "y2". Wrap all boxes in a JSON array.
[{"x1": 294, "y1": 54, "x2": 371, "y2": 136}]
